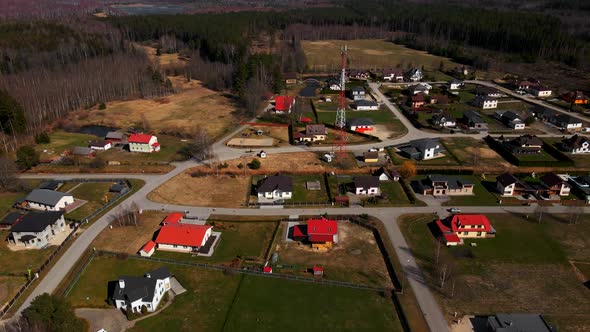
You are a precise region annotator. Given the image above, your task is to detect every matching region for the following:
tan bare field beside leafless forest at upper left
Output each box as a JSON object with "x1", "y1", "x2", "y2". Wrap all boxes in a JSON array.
[{"x1": 70, "y1": 81, "x2": 240, "y2": 137}]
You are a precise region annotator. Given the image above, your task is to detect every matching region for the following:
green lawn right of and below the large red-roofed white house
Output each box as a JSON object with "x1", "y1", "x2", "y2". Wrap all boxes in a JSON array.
[{"x1": 154, "y1": 221, "x2": 276, "y2": 264}]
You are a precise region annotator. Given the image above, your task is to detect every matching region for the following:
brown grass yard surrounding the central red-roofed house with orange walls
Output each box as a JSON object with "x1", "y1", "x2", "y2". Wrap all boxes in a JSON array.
[{"x1": 275, "y1": 222, "x2": 393, "y2": 287}]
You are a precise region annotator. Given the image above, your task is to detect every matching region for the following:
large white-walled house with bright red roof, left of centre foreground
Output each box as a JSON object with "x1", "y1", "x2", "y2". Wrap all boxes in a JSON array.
[{"x1": 156, "y1": 223, "x2": 213, "y2": 252}]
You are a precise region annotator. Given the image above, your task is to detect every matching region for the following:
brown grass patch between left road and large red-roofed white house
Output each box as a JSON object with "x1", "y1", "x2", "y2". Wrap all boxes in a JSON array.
[{"x1": 92, "y1": 211, "x2": 166, "y2": 255}]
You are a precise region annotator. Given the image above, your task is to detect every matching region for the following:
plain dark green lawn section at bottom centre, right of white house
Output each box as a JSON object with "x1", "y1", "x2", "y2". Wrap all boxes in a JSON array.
[{"x1": 223, "y1": 276, "x2": 402, "y2": 331}]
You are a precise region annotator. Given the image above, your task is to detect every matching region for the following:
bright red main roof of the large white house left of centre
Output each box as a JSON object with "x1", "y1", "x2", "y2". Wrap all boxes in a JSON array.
[{"x1": 156, "y1": 224, "x2": 213, "y2": 247}]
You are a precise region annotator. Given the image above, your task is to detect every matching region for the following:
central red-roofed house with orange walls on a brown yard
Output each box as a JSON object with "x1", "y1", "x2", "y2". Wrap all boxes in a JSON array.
[{"x1": 291, "y1": 217, "x2": 338, "y2": 251}]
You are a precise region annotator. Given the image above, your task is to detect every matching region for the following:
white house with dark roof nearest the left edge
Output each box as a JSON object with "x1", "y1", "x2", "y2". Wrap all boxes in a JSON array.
[{"x1": 8, "y1": 211, "x2": 66, "y2": 248}]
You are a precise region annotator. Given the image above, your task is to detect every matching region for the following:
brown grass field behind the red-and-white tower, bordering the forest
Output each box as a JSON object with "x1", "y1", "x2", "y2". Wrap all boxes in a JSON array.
[{"x1": 302, "y1": 39, "x2": 457, "y2": 71}]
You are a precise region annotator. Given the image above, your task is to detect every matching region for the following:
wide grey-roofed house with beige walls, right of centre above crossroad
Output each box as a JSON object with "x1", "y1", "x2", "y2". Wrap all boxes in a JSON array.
[{"x1": 418, "y1": 174, "x2": 473, "y2": 196}]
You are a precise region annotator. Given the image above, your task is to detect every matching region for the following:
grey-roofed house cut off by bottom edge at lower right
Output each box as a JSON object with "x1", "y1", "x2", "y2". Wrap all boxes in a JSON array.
[{"x1": 486, "y1": 313, "x2": 556, "y2": 332}]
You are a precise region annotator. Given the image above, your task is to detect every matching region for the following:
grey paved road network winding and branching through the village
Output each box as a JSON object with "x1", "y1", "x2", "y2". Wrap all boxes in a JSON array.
[{"x1": 6, "y1": 81, "x2": 590, "y2": 332}]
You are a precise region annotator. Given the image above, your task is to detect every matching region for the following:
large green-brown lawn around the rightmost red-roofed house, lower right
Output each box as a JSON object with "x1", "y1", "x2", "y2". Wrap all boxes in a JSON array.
[{"x1": 399, "y1": 214, "x2": 590, "y2": 331}]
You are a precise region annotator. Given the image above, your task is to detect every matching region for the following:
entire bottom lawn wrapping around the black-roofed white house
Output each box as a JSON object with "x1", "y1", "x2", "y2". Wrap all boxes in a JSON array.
[{"x1": 68, "y1": 256, "x2": 401, "y2": 331}]
